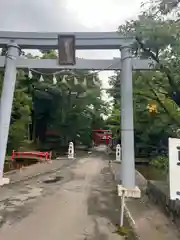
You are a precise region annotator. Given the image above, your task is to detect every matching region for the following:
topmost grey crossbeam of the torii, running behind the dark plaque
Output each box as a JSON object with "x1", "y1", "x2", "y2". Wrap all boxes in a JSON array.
[{"x1": 0, "y1": 31, "x2": 135, "y2": 50}]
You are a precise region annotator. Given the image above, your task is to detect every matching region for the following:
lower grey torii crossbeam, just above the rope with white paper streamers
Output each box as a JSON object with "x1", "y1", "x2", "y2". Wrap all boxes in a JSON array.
[{"x1": 0, "y1": 56, "x2": 155, "y2": 71}]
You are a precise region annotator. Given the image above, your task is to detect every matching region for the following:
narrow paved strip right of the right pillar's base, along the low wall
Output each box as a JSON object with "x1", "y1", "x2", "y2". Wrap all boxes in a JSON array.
[{"x1": 112, "y1": 162, "x2": 180, "y2": 240}]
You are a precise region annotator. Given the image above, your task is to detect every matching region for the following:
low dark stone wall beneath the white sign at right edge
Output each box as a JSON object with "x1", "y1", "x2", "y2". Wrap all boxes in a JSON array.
[{"x1": 146, "y1": 181, "x2": 180, "y2": 229}]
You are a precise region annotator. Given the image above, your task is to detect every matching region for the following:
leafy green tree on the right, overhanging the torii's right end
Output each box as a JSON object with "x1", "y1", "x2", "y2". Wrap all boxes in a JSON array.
[{"x1": 108, "y1": 0, "x2": 180, "y2": 159}]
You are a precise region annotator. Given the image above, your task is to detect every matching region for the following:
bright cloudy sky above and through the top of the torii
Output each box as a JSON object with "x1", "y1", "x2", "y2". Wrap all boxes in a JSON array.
[{"x1": 0, "y1": 0, "x2": 142, "y2": 91}]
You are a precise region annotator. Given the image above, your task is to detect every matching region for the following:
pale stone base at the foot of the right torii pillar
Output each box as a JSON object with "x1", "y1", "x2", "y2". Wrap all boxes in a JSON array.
[{"x1": 117, "y1": 185, "x2": 141, "y2": 198}]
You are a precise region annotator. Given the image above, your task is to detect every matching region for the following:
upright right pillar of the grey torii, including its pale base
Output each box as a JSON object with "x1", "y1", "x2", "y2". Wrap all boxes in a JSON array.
[{"x1": 118, "y1": 46, "x2": 141, "y2": 199}]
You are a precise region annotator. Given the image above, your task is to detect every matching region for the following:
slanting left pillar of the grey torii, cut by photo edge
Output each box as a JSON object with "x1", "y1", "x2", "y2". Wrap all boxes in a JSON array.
[{"x1": 0, "y1": 41, "x2": 20, "y2": 185}]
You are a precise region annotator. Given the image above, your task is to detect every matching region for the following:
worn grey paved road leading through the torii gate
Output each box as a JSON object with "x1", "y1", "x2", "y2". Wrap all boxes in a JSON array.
[{"x1": 0, "y1": 157, "x2": 123, "y2": 240}]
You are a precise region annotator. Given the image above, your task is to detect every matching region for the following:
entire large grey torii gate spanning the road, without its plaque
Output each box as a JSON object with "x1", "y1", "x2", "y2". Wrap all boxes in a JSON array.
[{"x1": 0, "y1": 32, "x2": 155, "y2": 195}]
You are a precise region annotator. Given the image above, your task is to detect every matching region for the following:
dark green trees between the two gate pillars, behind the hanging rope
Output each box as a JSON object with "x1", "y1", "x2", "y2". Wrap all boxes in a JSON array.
[{"x1": 0, "y1": 51, "x2": 108, "y2": 152}]
